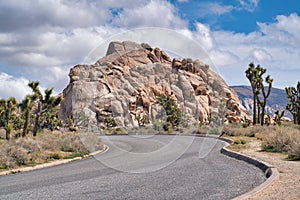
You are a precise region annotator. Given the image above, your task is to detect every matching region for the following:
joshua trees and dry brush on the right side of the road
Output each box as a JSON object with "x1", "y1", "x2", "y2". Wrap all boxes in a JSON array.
[{"x1": 223, "y1": 63, "x2": 300, "y2": 160}]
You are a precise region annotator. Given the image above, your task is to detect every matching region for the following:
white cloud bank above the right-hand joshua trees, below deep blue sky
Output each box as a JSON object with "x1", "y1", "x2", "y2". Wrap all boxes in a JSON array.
[{"x1": 212, "y1": 14, "x2": 300, "y2": 87}]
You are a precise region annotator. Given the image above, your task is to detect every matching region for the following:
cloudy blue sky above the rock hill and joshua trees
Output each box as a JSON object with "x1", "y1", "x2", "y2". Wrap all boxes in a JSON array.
[{"x1": 0, "y1": 0, "x2": 300, "y2": 99}]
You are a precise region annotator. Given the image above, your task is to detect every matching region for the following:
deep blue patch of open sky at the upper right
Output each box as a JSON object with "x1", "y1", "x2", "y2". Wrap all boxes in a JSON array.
[{"x1": 171, "y1": 0, "x2": 300, "y2": 33}]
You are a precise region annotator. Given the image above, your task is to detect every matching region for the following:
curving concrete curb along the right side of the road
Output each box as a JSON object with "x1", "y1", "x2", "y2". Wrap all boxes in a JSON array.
[{"x1": 220, "y1": 138, "x2": 279, "y2": 200}]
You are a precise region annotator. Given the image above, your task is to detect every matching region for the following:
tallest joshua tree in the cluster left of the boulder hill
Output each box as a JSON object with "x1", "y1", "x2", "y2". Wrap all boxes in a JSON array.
[{"x1": 28, "y1": 81, "x2": 62, "y2": 136}]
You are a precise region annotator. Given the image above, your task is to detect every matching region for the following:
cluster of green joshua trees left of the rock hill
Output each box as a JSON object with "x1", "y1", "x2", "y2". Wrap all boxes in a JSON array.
[{"x1": 0, "y1": 81, "x2": 63, "y2": 140}]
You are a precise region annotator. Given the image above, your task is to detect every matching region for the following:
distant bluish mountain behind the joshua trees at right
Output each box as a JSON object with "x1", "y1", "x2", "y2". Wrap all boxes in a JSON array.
[{"x1": 230, "y1": 86, "x2": 292, "y2": 118}]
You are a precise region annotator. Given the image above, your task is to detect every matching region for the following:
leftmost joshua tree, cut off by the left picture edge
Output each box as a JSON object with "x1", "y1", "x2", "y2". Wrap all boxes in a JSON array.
[{"x1": 0, "y1": 97, "x2": 18, "y2": 140}]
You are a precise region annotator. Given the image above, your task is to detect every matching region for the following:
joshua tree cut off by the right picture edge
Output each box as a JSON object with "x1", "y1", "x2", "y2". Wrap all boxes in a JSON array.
[{"x1": 285, "y1": 81, "x2": 300, "y2": 124}]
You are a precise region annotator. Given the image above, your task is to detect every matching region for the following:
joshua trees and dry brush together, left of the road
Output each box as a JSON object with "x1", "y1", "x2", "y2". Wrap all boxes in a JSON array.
[{"x1": 0, "y1": 81, "x2": 103, "y2": 170}]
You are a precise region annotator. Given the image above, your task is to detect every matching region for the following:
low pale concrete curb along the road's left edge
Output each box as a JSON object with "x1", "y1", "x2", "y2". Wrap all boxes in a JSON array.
[{"x1": 0, "y1": 144, "x2": 109, "y2": 176}]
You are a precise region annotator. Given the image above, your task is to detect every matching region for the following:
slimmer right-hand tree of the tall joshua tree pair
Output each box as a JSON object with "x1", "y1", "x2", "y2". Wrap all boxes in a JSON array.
[{"x1": 259, "y1": 75, "x2": 273, "y2": 126}]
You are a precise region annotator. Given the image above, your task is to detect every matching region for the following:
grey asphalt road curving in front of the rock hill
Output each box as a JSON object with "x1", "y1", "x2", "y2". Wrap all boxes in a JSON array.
[{"x1": 0, "y1": 135, "x2": 265, "y2": 200}]
